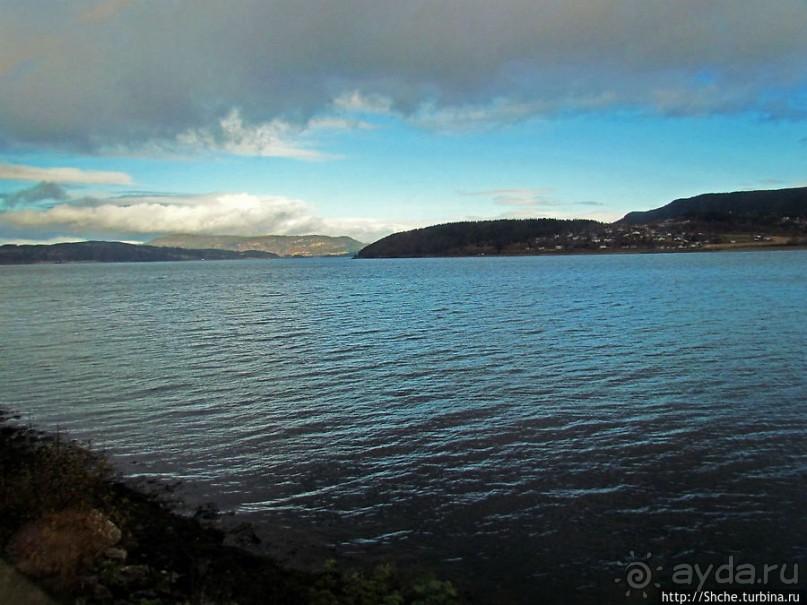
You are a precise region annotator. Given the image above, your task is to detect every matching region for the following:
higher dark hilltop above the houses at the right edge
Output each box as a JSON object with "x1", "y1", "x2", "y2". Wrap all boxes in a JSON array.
[{"x1": 618, "y1": 187, "x2": 807, "y2": 227}]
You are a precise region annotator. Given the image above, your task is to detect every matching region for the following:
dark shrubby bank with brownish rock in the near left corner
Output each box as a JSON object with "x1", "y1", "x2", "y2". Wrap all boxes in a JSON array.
[{"x1": 0, "y1": 412, "x2": 464, "y2": 605}]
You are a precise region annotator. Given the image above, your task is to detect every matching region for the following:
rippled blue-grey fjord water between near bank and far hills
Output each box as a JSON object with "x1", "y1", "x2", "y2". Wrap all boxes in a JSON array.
[{"x1": 0, "y1": 251, "x2": 807, "y2": 603}]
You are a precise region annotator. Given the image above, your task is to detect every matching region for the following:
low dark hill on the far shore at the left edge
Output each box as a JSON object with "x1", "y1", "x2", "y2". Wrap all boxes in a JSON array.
[{"x1": 0, "y1": 242, "x2": 277, "y2": 265}]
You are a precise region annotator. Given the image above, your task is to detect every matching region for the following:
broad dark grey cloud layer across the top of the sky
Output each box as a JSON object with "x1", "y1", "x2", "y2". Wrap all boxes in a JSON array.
[{"x1": 0, "y1": 0, "x2": 807, "y2": 149}]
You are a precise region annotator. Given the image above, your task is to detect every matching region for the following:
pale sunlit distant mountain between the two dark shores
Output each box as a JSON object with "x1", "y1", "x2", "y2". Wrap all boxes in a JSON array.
[{"x1": 148, "y1": 233, "x2": 364, "y2": 256}]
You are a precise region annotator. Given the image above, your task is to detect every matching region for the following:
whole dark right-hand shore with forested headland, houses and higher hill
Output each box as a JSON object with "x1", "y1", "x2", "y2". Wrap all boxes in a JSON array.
[{"x1": 357, "y1": 187, "x2": 807, "y2": 258}]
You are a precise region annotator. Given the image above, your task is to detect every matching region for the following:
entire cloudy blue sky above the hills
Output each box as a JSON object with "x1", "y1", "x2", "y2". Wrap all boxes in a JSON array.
[{"x1": 0, "y1": 0, "x2": 807, "y2": 244}]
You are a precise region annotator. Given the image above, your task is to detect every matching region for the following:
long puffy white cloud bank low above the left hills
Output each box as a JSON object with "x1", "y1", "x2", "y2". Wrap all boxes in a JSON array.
[{"x1": 0, "y1": 193, "x2": 406, "y2": 241}]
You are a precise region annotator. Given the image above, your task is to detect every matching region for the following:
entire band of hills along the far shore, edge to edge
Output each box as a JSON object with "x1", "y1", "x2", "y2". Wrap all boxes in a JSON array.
[{"x1": 0, "y1": 187, "x2": 807, "y2": 264}]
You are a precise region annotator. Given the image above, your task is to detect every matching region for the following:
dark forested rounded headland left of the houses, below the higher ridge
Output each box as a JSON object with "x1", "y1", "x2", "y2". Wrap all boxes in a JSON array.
[{"x1": 356, "y1": 218, "x2": 603, "y2": 258}]
